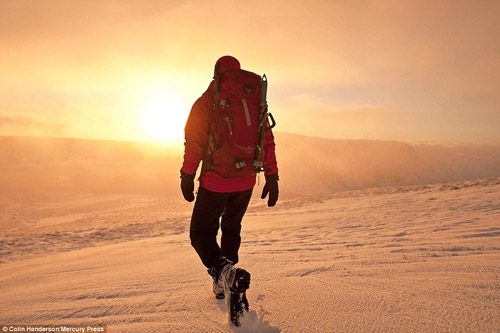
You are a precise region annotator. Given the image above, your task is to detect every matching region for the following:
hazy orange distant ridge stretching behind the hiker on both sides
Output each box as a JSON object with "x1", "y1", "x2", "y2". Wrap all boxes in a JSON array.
[{"x1": 0, "y1": 132, "x2": 500, "y2": 194}]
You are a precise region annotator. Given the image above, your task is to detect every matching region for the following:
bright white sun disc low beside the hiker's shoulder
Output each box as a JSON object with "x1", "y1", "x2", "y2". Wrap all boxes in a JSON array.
[{"x1": 140, "y1": 93, "x2": 188, "y2": 142}]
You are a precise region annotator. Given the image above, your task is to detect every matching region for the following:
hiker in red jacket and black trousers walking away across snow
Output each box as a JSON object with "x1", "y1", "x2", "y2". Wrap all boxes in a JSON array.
[{"x1": 181, "y1": 56, "x2": 279, "y2": 322}]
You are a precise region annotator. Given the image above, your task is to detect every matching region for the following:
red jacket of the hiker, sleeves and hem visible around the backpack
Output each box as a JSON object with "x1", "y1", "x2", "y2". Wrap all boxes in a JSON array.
[{"x1": 181, "y1": 81, "x2": 278, "y2": 192}]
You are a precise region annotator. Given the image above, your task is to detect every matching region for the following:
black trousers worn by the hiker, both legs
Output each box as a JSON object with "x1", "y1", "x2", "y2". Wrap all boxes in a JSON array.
[{"x1": 189, "y1": 186, "x2": 252, "y2": 269}]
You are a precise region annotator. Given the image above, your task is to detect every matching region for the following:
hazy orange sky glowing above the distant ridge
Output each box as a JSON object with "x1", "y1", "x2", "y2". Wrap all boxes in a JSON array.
[{"x1": 0, "y1": 0, "x2": 500, "y2": 144}]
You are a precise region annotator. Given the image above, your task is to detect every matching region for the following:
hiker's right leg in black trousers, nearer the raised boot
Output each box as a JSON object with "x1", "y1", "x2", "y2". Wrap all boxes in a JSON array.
[{"x1": 221, "y1": 189, "x2": 252, "y2": 264}]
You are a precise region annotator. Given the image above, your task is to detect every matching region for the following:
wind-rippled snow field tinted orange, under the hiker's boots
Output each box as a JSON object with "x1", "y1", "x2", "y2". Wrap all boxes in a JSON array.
[{"x1": 0, "y1": 136, "x2": 500, "y2": 332}]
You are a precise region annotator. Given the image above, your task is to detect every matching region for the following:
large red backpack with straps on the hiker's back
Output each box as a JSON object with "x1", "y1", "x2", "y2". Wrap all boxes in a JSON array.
[{"x1": 203, "y1": 69, "x2": 274, "y2": 178}]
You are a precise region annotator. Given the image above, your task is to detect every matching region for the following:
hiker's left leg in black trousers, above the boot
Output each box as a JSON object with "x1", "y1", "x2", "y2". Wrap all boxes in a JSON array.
[{"x1": 189, "y1": 186, "x2": 229, "y2": 269}]
